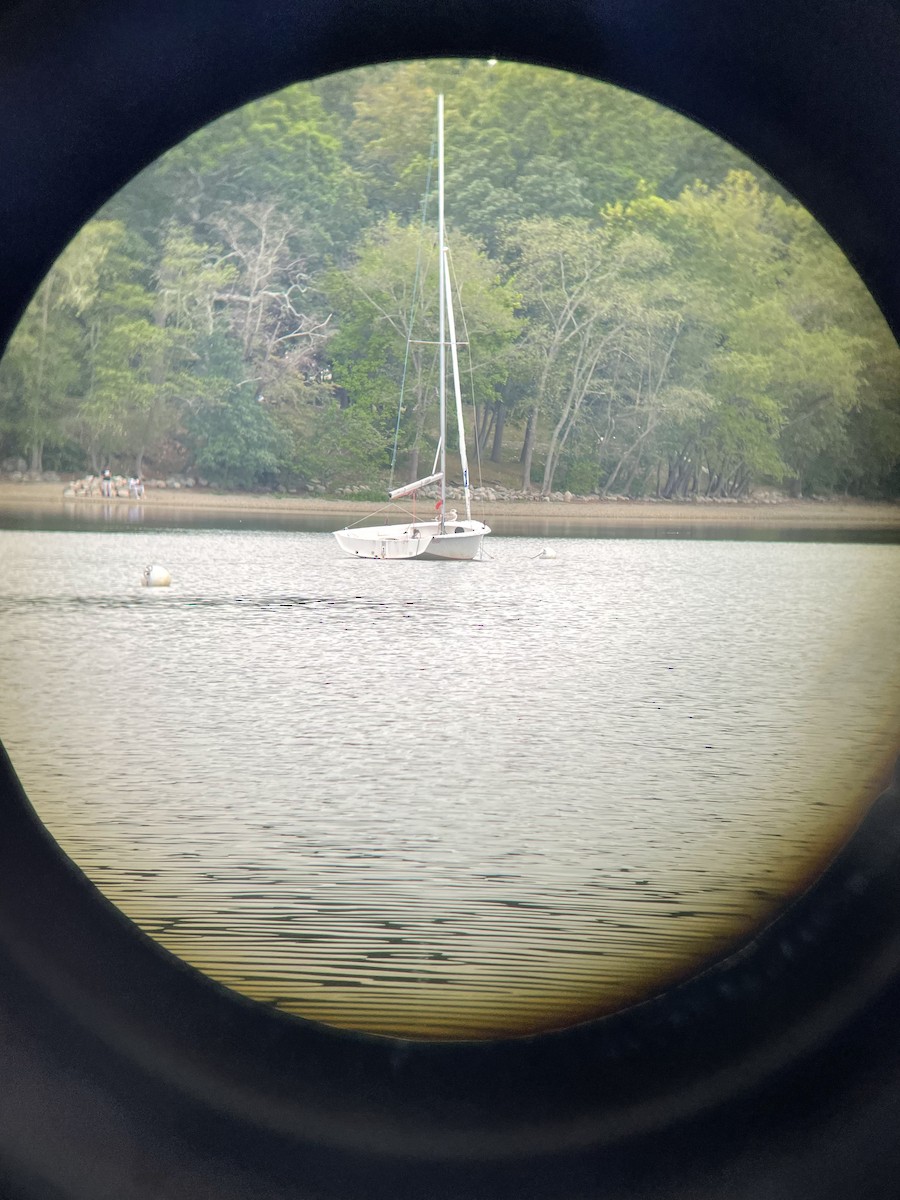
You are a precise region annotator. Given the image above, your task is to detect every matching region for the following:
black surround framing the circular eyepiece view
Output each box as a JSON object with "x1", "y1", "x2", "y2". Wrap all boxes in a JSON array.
[{"x1": 0, "y1": 0, "x2": 900, "y2": 1200}]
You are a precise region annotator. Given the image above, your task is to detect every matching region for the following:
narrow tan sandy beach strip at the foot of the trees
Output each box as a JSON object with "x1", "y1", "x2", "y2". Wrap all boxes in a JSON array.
[{"x1": 0, "y1": 480, "x2": 900, "y2": 532}]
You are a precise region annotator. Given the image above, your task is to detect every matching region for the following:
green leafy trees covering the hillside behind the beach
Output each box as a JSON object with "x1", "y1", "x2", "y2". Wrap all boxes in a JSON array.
[{"x1": 0, "y1": 60, "x2": 900, "y2": 498}]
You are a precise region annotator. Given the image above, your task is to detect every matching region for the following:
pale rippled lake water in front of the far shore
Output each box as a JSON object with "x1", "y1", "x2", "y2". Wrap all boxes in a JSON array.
[{"x1": 0, "y1": 528, "x2": 900, "y2": 1037}]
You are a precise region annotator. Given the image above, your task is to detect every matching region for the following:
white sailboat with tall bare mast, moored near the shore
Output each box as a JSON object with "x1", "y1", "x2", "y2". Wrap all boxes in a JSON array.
[{"x1": 335, "y1": 96, "x2": 491, "y2": 562}]
